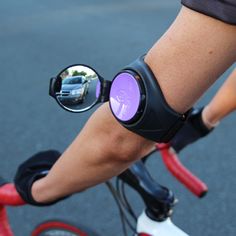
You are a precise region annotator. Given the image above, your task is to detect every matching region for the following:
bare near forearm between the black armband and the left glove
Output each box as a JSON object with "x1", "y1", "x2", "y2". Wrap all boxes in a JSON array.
[{"x1": 32, "y1": 104, "x2": 153, "y2": 202}]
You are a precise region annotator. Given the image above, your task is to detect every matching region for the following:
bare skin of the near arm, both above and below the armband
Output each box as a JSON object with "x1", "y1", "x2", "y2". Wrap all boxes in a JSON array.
[{"x1": 32, "y1": 7, "x2": 236, "y2": 202}]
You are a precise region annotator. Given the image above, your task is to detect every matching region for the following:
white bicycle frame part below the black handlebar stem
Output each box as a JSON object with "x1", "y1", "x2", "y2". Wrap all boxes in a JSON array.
[{"x1": 137, "y1": 212, "x2": 189, "y2": 236}]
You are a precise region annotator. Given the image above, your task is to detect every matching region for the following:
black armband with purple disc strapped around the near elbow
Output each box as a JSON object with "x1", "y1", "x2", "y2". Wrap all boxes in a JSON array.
[{"x1": 109, "y1": 56, "x2": 189, "y2": 142}]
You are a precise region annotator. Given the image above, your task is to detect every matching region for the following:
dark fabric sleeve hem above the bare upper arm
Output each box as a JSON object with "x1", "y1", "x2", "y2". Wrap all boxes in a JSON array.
[{"x1": 181, "y1": 0, "x2": 236, "y2": 25}]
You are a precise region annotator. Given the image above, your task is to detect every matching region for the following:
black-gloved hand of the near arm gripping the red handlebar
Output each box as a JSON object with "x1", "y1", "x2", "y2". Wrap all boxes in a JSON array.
[{"x1": 14, "y1": 150, "x2": 61, "y2": 206}]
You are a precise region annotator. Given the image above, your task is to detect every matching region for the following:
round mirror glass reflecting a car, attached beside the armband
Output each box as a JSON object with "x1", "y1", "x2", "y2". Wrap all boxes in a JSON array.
[{"x1": 55, "y1": 65, "x2": 101, "y2": 112}]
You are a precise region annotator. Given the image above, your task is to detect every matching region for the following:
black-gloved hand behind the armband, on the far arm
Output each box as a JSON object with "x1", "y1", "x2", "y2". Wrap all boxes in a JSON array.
[{"x1": 170, "y1": 108, "x2": 213, "y2": 152}]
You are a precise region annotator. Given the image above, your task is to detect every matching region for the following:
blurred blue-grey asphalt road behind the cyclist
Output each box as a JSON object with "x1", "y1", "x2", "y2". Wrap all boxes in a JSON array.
[{"x1": 0, "y1": 0, "x2": 236, "y2": 236}]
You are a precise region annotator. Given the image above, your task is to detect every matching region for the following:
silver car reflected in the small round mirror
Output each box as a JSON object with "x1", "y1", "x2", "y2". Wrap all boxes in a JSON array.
[{"x1": 58, "y1": 76, "x2": 89, "y2": 105}]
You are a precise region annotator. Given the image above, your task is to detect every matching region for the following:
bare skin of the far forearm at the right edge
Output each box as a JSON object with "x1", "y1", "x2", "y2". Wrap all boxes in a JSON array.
[{"x1": 202, "y1": 69, "x2": 236, "y2": 128}]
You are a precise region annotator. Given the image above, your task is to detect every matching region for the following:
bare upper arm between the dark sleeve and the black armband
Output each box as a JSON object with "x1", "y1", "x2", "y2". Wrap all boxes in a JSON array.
[{"x1": 146, "y1": 7, "x2": 236, "y2": 112}]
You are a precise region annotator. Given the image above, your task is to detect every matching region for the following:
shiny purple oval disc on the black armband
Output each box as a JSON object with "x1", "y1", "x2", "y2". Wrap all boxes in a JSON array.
[{"x1": 110, "y1": 72, "x2": 140, "y2": 121}]
